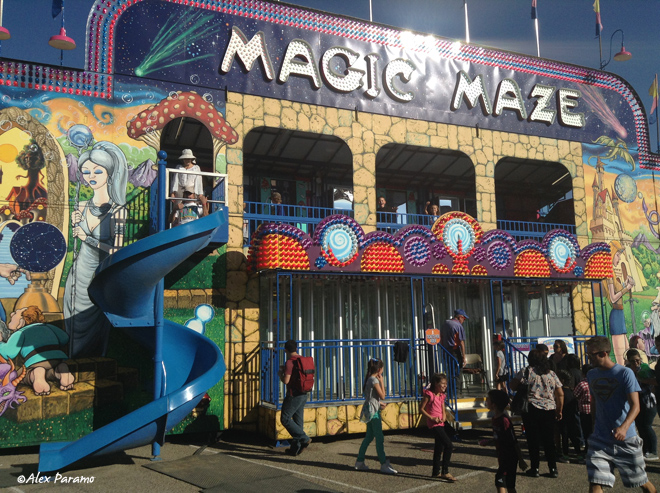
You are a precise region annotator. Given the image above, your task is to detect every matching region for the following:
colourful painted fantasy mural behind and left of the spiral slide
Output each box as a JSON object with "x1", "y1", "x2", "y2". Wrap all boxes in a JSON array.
[{"x1": 0, "y1": 77, "x2": 231, "y2": 446}]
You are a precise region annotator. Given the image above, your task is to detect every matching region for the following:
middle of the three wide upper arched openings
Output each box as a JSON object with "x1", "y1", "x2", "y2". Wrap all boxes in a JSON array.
[{"x1": 376, "y1": 144, "x2": 477, "y2": 230}]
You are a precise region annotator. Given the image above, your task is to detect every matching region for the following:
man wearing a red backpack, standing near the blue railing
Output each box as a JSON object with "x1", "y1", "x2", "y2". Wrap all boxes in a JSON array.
[{"x1": 280, "y1": 339, "x2": 315, "y2": 456}]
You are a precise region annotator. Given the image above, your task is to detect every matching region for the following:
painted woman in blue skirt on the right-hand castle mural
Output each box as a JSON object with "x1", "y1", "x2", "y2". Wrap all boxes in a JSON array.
[{"x1": 607, "y1": 240, "x2": 635, "y2": 365}]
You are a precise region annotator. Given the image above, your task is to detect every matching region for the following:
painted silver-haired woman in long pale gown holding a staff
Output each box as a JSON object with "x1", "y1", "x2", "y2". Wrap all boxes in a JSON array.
[{"x1": 64, "y1": 142, "x2": 128, "y2": 358}]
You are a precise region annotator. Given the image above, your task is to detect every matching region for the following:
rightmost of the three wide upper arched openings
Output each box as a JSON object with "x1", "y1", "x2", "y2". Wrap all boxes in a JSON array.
[{"x1": 495, "y1": 158, "x2": 575, "y2": 235}]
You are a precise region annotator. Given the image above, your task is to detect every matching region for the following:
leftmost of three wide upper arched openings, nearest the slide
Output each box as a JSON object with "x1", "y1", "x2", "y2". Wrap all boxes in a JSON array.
[{"x1": 243, "y1": 127, "x2": 353, "y2": 243}]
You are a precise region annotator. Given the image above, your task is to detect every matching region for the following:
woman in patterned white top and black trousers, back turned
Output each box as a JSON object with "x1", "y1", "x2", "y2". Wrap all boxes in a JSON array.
[{"x1": 511, "y1": 349, "x2": 564, "y2": 478}]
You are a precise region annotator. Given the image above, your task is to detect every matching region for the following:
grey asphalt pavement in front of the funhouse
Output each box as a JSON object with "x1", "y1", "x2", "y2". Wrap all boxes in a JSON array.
[{"x1": 0, "y1": 418, "x2": 660, "y2": 493}]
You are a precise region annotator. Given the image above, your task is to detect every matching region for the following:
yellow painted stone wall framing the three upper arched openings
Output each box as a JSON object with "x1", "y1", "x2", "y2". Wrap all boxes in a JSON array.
[{"x1": 225, "y1": 93, "x2": 593, "y2": 435}]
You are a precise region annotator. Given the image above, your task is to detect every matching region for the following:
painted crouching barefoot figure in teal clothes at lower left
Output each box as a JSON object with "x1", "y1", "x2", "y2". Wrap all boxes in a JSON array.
[{"x1": 0, "y1": 306, "x2": 75, "y2": 395}]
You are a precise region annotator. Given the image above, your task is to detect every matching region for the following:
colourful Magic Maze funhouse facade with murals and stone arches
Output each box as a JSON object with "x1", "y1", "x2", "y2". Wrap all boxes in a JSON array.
[{"x1": 0, "y1": 0, "x2": 660, "y2": 446}]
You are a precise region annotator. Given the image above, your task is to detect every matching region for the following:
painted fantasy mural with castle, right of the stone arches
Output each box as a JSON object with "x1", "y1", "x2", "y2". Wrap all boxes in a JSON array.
[{"x1": 583, "y1": 136, "x2": 660, "y2": 364}]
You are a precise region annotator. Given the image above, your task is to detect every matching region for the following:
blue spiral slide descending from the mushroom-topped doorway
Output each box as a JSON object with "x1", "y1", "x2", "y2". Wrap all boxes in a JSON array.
[{"x1": 39, "y1": 208, "x2": 228, "y2": 472}]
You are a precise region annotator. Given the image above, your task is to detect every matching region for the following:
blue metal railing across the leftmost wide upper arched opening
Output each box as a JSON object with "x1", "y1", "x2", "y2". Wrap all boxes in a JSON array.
[{"x1": 243, "y1": 202, "x2": 353, "y2": 245}]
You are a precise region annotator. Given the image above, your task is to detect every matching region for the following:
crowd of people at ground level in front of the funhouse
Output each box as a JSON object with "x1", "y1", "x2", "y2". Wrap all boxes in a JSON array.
[{"x1": 280, "y1": 332, "x2": 660, "y2": 493}]
